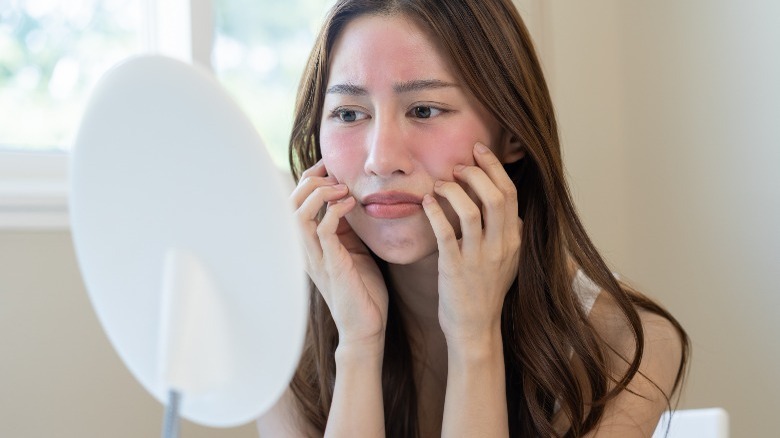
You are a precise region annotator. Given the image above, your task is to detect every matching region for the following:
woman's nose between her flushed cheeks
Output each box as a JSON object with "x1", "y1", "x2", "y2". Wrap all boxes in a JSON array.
[{"x1": 364, "y1": 117, "x2": 413, "y2": 177}]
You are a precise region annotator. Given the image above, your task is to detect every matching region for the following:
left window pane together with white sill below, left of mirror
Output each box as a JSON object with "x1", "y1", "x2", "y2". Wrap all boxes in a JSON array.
[{"x1": 0, "y1": 0, "x2": 148, "y2": 229}]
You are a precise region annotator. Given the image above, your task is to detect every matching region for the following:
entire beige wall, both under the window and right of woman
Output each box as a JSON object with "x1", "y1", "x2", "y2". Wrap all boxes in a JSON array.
[{"x1": 0, "y1": 0, "x2": 780, "y2": 438}]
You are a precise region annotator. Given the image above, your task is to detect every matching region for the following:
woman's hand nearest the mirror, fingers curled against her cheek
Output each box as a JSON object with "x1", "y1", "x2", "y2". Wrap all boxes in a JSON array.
[{"x1": 291, "y1": 160, "x2": 388, "y2": 353}]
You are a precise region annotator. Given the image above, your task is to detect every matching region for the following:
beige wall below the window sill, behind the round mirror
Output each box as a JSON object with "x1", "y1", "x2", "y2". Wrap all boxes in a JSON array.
[{"x1": 0, "y1": 231, "x2": 257, "y2": 438}]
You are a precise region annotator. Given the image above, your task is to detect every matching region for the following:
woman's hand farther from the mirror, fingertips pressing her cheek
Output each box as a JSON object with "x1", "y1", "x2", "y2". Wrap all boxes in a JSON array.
[{"x1": 423, "y1": 143, "x2": 522, "y2": 352}]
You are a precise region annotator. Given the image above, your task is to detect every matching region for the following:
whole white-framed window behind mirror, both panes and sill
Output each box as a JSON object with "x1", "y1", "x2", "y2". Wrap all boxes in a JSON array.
[{"x1": 0, "y1": 0, "x2": 332, "y2": 229}]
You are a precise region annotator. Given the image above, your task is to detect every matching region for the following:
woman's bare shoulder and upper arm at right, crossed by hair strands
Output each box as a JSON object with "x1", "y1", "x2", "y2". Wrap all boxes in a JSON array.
[{"x1": 589, "y1": 292, "x2": 683, "y2": 437}]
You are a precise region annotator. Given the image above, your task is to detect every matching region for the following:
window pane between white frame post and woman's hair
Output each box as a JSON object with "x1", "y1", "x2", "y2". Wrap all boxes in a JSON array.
[{"x1": 212, "y1": 0, "x2": 332, "y2": 167}]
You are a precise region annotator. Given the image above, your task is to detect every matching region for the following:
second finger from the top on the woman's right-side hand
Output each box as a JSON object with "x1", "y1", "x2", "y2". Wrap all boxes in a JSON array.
[{"x1": 454, "y1": 166, "x2": 511, "y2": 248}]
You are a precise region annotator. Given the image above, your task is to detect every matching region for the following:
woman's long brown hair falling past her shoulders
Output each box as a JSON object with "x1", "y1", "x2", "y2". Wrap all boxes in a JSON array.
[{"x1": 289, "y1": 0, "x2": 689, "y2": 437}]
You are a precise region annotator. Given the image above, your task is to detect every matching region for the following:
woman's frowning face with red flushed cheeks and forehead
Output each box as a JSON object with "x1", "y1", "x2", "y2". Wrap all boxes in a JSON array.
[{"x1": 320, "y1": 15, "x2": 501, "y2": 264}]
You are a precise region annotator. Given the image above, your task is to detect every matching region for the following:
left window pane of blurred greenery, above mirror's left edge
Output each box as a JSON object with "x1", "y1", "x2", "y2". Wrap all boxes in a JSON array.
[{"x1": 0, "y1": 0, "x2": 145, "y2": 150}]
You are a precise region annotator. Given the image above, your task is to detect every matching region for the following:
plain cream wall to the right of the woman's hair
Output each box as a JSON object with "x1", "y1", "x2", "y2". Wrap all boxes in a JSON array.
[{"x1": 542, "y1": 0, "x2": 780, "y2": 437}]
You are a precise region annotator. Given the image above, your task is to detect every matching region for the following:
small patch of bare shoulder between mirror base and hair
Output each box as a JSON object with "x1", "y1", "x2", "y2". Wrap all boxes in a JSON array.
[{"x1": 257, "y1": 388, "x2": 322, "y2": 438}]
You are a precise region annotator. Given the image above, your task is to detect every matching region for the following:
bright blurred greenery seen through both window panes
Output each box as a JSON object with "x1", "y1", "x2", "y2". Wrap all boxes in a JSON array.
[{"x1": 0, "y1": 0, "x2": 330, "y2": 166}]
